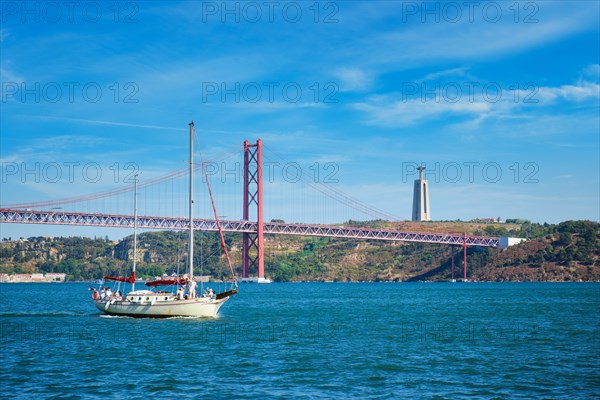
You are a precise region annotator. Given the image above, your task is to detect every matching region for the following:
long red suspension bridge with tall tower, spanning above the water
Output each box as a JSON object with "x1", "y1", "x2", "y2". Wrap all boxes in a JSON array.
[{"x1": 0, "y1": 139, "x2": 499, "y2": 280}]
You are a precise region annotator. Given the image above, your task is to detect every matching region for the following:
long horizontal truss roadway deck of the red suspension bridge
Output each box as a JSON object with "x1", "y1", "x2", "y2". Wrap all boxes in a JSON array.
[{"x1": 0, "y1": 208, "x2": 499, "y2": 247}]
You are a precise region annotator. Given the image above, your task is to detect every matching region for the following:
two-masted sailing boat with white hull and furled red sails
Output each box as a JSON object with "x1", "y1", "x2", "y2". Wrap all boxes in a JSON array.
[{"x1": 92, "y1": 121, "x2": 237, "y2": 318}]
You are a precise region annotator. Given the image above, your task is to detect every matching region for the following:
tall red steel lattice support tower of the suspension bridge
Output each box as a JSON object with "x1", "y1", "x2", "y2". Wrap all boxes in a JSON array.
[{"x1": 242, "y1": 139, "x2": 265, "y2": 278}]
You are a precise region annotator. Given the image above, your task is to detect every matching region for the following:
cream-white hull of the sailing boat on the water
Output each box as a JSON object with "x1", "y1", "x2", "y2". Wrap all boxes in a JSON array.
[{"x1": 94, "y1": 297, "x2": 229, "y2": 318}]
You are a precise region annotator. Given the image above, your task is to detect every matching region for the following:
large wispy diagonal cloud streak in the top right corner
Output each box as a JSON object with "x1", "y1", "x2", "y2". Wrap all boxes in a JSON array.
[{"x1": 335, "y1": 1, "x2": 598, "y2": 83}]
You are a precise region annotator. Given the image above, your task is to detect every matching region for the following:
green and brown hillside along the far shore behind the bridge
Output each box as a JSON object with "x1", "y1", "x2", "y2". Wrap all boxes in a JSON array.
[{"x1": 0, "y1": 221, "x2": 600, "y2": 281}]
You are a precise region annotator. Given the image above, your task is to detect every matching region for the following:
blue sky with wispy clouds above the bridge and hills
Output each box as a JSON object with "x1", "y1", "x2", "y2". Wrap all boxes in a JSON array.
[{"x1": 0, "y1": 0, "x2": 600, "y2": 238}]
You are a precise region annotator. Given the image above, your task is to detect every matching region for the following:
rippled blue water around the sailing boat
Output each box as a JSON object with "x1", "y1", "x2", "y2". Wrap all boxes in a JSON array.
[{"x1": 0, "y1": 283, "x2": 600, "y2": 399}]
